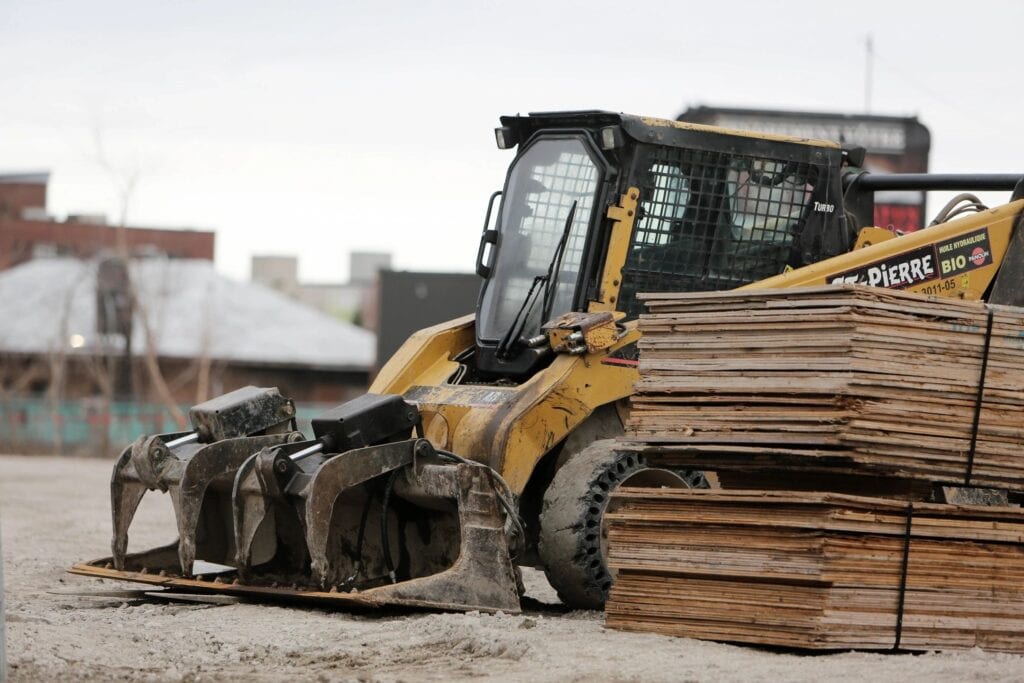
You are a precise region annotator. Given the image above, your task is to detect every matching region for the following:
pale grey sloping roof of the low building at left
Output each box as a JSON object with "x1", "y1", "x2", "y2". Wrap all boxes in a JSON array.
[{"x1": 0, "y1": 258, "x2": 376, "y2": 370}]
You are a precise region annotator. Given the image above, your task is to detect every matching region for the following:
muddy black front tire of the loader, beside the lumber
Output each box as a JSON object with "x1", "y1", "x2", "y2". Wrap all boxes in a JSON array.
[{"x1": 538, "y1": 439, "x2": 707, "y2": 609}]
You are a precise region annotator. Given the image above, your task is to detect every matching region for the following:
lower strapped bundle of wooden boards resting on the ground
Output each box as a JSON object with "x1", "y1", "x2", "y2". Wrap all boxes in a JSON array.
[{"x1": 605, "y1": 488, "x2": 1024, "y2": 652}]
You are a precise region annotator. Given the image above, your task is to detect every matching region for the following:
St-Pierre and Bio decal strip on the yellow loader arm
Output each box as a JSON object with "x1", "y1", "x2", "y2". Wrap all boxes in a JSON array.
[{"x1": 829, "y1": 227, "x2": 992, "y2": 290}]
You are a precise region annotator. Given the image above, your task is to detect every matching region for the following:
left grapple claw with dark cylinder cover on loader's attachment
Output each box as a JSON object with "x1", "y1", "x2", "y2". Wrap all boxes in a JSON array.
[{"x1": 111, "y1": 386, "x2": 301, "y2": 575}]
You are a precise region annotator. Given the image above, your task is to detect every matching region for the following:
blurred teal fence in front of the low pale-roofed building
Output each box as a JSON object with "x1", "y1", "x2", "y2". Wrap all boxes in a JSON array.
[{"x1": 0, "y1": 398, "x2": 330, "y2": 456}]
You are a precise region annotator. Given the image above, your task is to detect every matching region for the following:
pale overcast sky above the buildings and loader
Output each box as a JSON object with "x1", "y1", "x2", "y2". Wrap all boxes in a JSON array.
[{"x1": 0, "y1": 0, "x2": 1024, "y2": 282}]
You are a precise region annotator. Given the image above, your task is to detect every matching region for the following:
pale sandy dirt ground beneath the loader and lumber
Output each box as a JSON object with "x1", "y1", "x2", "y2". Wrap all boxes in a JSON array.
[{"x1": 6, "y1": 456, "x2": 1024, "y2": 683}]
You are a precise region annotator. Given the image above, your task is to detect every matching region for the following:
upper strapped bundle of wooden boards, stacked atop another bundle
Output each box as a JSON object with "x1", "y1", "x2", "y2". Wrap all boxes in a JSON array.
[{"x1": 626, "y1": 286, "x2": 1024, "y2": 489}]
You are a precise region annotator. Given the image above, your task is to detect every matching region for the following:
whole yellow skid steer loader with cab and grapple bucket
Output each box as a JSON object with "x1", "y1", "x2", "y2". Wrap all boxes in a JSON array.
[{"x1": 73, "y1": 112, "x2": 1024, "y2": 612}]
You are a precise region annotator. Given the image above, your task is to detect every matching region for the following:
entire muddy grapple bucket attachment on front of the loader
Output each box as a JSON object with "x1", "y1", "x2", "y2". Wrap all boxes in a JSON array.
[{"x1": 81, "y1": 389, "x2": 522, "y2": 613}]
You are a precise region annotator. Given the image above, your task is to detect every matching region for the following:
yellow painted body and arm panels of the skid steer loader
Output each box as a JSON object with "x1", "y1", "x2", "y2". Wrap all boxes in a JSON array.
[{"x1": 371, "y1": 197, "x2": 1024, "y2": 494}]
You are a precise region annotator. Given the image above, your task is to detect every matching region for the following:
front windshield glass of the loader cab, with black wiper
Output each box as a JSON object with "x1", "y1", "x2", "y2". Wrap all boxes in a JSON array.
[{"x1": 477, "y1": 137, "x2": 601, "y2": 341}]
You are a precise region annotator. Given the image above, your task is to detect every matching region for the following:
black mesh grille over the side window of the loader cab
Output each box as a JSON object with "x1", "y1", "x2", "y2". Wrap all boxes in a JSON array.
[{"x1": 620, "y1": 147, "x2": 817, "y2": 317}]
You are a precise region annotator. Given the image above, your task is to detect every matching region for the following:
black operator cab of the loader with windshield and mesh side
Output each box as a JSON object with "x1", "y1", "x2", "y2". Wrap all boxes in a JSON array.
[{"x1": 463, "y1": 112, "x2": 853, "y2": 383}]
